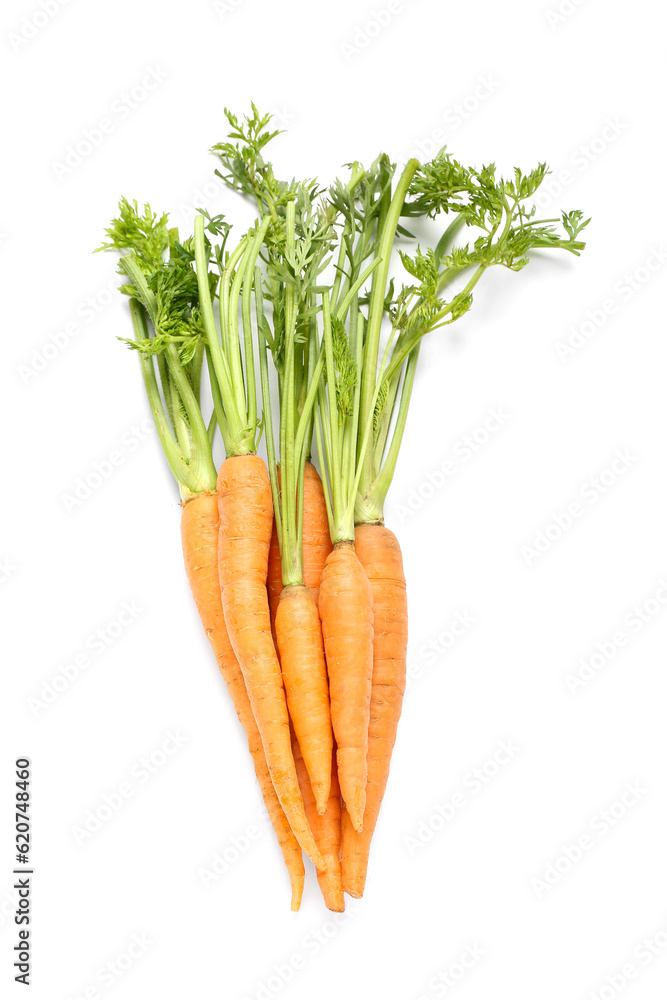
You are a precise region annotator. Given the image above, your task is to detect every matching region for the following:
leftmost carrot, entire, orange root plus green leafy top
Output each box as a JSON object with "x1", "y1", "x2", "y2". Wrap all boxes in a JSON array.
[{"x1": 98, "y1": 205, "x2": 314, "y2": 909}]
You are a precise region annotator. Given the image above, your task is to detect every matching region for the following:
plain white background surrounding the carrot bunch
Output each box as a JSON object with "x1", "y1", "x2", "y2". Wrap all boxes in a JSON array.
[{"x1": 0, "y1": 0, "x2": 667, "y2": 1000}]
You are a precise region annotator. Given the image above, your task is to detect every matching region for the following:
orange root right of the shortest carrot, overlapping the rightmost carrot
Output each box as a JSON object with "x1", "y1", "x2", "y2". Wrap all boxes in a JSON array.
[{"x1": 320, "y1": 541, "x2": 373, "y2": 832}]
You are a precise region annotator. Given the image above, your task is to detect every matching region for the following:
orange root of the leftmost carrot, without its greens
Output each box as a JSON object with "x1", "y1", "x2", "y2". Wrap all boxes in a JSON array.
[{"x1": 181, "y1": 493, "x2": 304, "y2": 910}]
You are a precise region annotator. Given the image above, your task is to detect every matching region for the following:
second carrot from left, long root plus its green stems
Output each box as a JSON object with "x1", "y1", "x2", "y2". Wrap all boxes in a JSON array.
[{"x1": 193, "y1": 215, "x2": 324, "y2": 868}]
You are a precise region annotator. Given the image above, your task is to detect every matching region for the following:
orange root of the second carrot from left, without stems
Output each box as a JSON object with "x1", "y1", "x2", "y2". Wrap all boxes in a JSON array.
[{"x1": 218, "y1": 455, "x2": 325, "y2": 868}]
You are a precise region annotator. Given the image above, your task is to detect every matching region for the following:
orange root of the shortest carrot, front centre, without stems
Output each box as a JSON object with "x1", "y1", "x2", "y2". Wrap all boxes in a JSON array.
[{"x1": 275, "y1": 585, "x2": 333, "y2": 812}]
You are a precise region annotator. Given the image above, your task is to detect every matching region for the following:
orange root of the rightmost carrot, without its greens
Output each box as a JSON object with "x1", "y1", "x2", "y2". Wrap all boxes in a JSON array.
[{"x1": 342, "y1": 524, "x2": 408, "y2": 898}]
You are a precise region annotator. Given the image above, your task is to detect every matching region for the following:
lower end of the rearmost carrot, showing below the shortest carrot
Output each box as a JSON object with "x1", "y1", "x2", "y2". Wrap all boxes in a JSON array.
[{"x1": 292, "y1": 737, "x2": 345, "y2": 913}]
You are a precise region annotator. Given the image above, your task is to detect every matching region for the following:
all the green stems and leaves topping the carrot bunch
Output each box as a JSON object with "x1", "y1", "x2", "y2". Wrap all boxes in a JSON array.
[{"x1": 100, "y1": 104, "x2": 589, "y2": 528}]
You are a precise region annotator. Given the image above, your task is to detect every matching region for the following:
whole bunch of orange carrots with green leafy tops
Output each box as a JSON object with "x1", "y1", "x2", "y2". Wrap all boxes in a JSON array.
[{"x1": 100, "y1": 105, "x2": 587, "y2": 911}]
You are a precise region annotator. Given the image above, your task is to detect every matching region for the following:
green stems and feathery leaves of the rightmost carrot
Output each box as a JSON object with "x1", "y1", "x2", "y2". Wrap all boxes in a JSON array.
[{"x1": 354, "y1": 156, "x2": 589, "y2": 523}]
